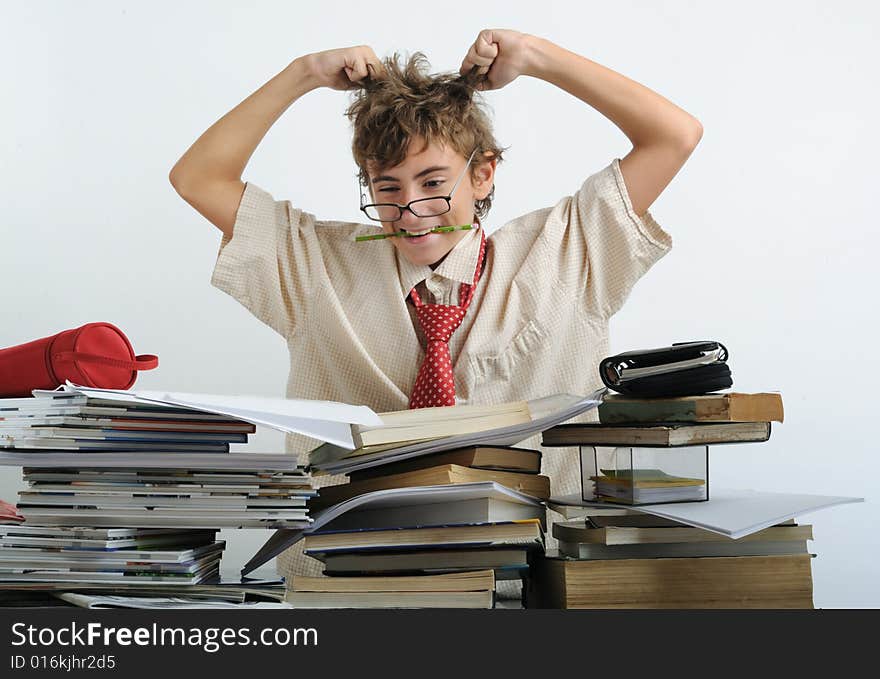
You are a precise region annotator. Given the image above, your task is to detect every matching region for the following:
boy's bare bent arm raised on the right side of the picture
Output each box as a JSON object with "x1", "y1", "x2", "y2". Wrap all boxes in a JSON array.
[{"x1": 461, "y1": 30, "x2": 703, "y2": 216}]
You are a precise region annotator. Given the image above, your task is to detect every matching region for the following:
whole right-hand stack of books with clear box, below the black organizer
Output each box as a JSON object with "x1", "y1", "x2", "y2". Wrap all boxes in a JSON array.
[{"x1": 528, "y1": 393, "x2": 813, "y2": 608}]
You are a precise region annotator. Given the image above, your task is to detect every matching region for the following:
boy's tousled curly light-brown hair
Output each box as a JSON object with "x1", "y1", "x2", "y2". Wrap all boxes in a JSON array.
[{"x1": 345, "y1": 52, "x2": 504, "y2": 218}]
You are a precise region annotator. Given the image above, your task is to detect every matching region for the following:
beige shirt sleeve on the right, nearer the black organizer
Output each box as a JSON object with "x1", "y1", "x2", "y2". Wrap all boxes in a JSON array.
[{"x1": 549, "y1": 158, "x2": 672, "y2": 317}]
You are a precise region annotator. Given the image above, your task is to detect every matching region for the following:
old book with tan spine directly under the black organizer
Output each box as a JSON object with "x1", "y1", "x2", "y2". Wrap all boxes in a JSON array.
[{"x1": 598, "y1": 392, "x2": 784, "y2": 424}]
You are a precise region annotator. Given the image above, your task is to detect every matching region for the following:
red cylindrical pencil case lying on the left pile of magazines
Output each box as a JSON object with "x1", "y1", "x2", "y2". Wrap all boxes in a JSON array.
[{"x1": 0, "y1": 323, "x2": 159, "y2": 398}]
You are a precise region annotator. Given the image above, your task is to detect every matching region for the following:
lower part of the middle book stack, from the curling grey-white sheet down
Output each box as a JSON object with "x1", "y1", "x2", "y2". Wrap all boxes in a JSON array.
[{"x1": 245, "y1": 481, "x2": 545, "y2": 608}]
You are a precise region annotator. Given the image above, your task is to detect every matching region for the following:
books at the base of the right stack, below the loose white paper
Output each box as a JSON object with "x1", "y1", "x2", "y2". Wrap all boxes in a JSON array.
[{"x1": 527, "y1": 508, "x2": 813, "y2": 609}]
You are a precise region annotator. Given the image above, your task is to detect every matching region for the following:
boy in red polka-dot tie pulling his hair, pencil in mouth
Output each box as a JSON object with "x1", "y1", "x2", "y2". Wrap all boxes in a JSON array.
[{"x1": 170, "y1": 30, "x2": 702, "y2": 572}]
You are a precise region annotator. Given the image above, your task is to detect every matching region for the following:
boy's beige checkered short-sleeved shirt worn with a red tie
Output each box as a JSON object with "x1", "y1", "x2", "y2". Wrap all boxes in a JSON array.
[{"x1": 211, "y1": 159, "x2": 672, "y2": 573}]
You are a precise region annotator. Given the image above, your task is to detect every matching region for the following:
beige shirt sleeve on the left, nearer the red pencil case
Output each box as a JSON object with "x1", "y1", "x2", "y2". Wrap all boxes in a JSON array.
[{"x1": 211, "y1": 182, "x2": 321, "y2": 338}]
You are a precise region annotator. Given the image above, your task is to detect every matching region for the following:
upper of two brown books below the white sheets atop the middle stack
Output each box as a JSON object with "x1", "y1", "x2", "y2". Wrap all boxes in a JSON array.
[{"x1": 348, "y1": 446, "x2": 541, "y2": 482}]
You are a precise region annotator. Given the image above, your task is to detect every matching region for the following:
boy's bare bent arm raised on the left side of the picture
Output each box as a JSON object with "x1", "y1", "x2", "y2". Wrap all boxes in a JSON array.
[{"x1": 169, "y1": 46, "x2": 382, "y2": 238}]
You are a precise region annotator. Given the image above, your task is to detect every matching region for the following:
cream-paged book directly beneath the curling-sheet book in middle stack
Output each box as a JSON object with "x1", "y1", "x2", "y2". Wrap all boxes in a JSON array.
[{"x1": 303, "y1": 519, "x2": 544, "y2": 554}]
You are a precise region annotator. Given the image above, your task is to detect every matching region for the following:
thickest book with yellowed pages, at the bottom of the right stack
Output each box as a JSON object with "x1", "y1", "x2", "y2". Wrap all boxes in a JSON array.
[{"x1": 527, "y1": 554, "x2": 813, "y2": 609}]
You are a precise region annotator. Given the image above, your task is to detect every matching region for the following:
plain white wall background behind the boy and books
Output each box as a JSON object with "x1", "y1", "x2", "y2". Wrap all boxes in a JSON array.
[{"x1": 0, "y1": 0, "x2": 880, "y2": 608}]
